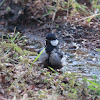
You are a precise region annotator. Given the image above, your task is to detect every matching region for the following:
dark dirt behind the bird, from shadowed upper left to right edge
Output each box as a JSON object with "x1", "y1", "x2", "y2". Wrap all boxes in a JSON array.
[{"x1": 0, "y1": 1, "x2": 100, "y2": 50}]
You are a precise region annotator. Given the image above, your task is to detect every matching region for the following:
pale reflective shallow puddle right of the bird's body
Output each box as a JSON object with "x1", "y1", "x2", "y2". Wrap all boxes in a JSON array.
[{"x1": 63, "y1": 49, "x2": 100, "y2": 78}]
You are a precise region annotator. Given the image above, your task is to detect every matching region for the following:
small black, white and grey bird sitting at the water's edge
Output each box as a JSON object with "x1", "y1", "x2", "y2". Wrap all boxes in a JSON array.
[{"x1": 39, "y1": 33, "x2": 63, "y2": 69}]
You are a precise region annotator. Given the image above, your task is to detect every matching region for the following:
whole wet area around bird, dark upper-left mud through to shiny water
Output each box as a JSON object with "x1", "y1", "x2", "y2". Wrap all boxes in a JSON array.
[{"x1": 0, "y1": 2, "x2": 100, "y2": 76}]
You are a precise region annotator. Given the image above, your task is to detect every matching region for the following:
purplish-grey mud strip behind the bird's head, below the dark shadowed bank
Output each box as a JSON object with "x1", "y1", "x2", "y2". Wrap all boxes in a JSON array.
[{"x1": 24, "y1": 23, "x2": 100, "y2": 50}]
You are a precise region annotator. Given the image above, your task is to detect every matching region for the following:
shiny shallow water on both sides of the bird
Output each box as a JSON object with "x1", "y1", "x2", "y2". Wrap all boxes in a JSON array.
[{"x1": 20, "y1": 39, "x2": 100, "y2": 80}]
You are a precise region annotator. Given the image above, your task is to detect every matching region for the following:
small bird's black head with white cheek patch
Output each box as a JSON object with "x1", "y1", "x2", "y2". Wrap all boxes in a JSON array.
[{"x1": 46, "y1": 33, "x2": 58, "y2": 47}]
